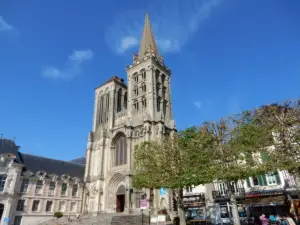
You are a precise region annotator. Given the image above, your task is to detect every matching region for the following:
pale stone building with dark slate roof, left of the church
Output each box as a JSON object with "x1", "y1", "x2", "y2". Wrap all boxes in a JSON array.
[{"x1": 0, "y1": 138, "x2": 84, "y2": 225}]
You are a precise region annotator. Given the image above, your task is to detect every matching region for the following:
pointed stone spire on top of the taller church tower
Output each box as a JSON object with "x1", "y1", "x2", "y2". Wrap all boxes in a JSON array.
[{"x1": 138, "y1": 13, "x2": 159, "y2": 59}]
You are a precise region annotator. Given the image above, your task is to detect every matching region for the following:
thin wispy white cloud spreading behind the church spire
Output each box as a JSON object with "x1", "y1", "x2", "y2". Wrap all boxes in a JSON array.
[{"x1": 106, "y1": 0, "x2": 224, "y2": 53}]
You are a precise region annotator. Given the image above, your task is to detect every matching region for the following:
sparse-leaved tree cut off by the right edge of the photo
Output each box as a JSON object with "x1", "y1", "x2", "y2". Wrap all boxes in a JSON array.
[{"x1": 255, "y1": 100, "x2": 300, "y2": 183}]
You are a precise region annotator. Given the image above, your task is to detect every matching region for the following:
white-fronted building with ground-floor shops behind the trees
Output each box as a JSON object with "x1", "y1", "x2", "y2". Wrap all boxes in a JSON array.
[{"x1": 184, "y1": 163, "x2": 298, "y2": 224}]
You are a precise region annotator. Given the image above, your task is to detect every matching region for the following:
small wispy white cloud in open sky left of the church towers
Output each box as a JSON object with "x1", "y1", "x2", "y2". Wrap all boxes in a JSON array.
[{"x1": 41, "y1": 49, "x2": 93, "y2": 80}]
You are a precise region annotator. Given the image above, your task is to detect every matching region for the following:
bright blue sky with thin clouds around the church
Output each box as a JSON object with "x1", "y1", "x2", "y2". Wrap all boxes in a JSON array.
[{"x1": 0, "y1": 0, "x2": 300, "y2": 160}]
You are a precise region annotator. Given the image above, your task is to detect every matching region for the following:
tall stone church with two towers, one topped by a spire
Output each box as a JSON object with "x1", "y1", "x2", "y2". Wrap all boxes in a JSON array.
[{"x1": 83, "y1": 14, "x2": 176, "y2": 213}]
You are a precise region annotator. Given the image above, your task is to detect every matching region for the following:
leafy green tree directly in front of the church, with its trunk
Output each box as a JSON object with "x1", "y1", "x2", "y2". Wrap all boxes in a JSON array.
[{"x1": 133, "y1": 130, "x2": 213, "y2": 224}]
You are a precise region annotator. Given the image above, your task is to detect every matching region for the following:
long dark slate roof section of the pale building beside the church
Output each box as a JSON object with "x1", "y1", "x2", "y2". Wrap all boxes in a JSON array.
[{"x1": 19, "y1": 152, "x2": 85, "y2": 179}]
